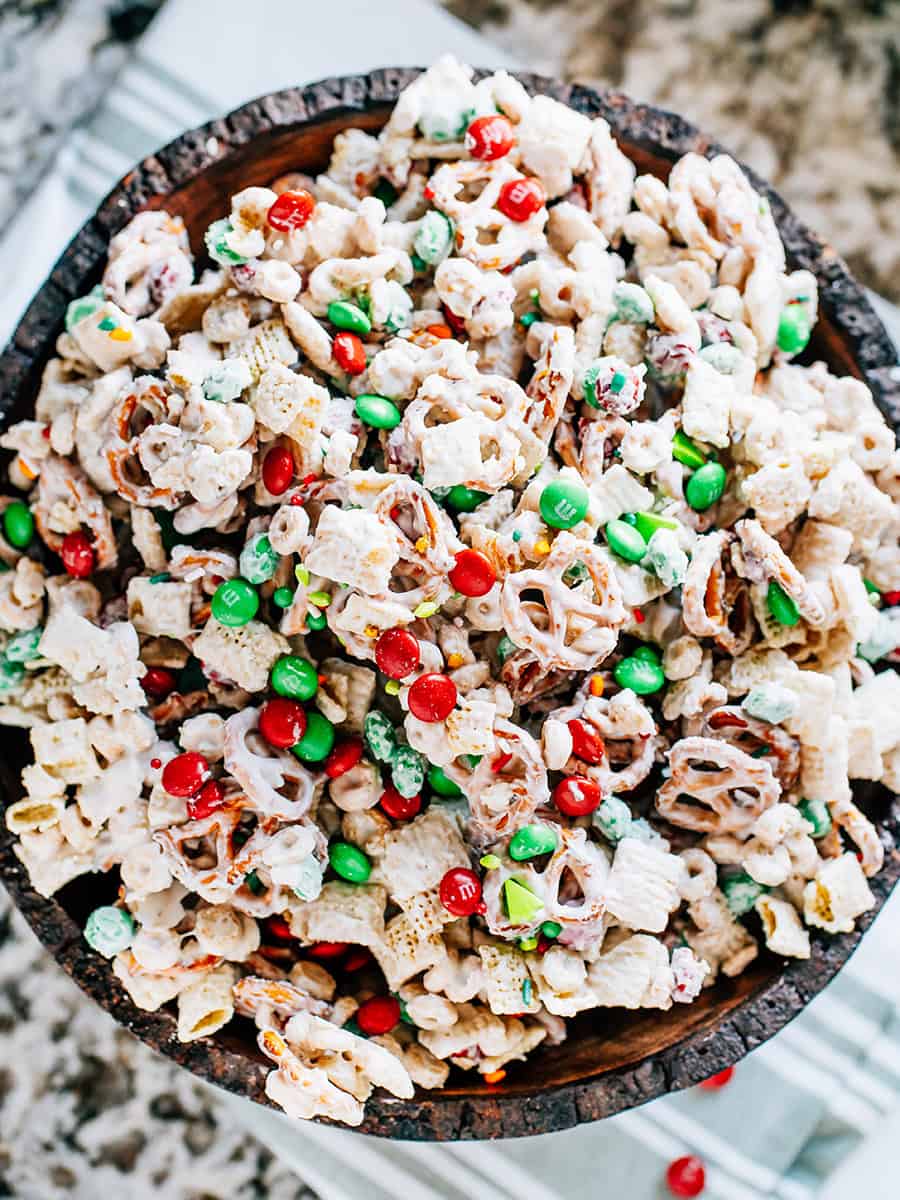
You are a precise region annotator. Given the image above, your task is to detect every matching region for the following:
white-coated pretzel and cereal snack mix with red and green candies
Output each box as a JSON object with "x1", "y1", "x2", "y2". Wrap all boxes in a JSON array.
[{"x1": 0, "y1": 58, "x2": 900, "y2": 1124}]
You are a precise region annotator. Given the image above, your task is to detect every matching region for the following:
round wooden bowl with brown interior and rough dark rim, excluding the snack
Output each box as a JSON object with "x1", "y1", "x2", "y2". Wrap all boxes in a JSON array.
[{"x1": 0, "y1": 68, "x2": 900, "y2": 1140}]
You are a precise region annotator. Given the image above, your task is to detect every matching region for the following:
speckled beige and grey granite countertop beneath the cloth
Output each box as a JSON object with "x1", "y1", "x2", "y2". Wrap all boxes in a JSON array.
[{"x1": 0, "y1": 0, "x2": 900, "y2": 1200}]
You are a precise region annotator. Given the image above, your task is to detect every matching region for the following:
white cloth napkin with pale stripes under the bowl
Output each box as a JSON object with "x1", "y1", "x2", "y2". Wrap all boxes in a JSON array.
[{"x1": 0, "y1": 9, "x2": 900, "y2": 1200}]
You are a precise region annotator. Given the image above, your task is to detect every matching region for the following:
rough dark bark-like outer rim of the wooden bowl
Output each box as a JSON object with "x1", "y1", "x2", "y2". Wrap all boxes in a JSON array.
[{"x1": 0, "y1": 67, "x2": 900, "y2": 1140}]
